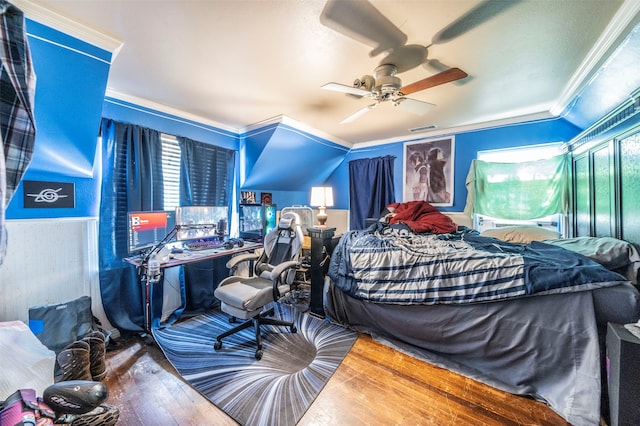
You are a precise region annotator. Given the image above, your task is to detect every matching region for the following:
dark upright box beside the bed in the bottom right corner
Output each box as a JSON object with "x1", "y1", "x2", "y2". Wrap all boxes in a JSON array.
[{"x1": 606, "y1": 323, "x2": 640, "y2": 426}]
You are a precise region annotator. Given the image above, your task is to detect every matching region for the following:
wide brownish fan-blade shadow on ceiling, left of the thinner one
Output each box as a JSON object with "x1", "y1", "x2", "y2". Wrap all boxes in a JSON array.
[{"x1": 320, "y1": 0, "x2": 407, "y2": 57}]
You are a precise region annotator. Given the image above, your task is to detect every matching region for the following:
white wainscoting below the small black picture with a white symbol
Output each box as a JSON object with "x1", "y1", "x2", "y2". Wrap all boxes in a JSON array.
[{"x1": 0, "y1": 218, "x2": 112, "y2": 328}]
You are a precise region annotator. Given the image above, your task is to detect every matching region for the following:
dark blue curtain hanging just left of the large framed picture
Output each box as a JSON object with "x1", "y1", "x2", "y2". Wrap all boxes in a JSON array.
[{"x1": 349, "y1": 155, "x2": 396, "y2": 229}]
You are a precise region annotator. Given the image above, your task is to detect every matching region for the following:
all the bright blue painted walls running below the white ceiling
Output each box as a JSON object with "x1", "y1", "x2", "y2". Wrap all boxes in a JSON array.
[{"x1": 12, "y1": 20, "x2": 580, "y2": 219}]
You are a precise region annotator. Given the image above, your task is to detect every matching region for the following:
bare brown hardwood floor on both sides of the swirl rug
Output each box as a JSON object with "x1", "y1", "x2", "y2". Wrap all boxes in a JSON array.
[{"x1": 105, "y1": 328, "x2": 568, "y2": 426}]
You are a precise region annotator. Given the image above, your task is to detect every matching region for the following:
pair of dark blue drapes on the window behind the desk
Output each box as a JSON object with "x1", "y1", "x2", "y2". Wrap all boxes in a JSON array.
[{"x1": 99, "y1": 119, "x2": 235, "y2": 331}]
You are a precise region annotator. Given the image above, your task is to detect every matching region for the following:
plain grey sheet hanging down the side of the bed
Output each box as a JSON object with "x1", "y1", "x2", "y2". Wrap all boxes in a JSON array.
[{"x1": 325, "y1": 279, "x2": 638, "y2": 425}]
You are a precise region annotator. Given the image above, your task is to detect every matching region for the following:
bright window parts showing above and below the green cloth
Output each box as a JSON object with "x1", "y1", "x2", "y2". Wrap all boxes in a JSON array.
[{"x1": 473, "y1": 142, "x2": 564, "y2": 234}]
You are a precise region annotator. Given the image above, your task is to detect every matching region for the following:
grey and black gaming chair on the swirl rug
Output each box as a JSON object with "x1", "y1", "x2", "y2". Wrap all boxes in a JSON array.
[{"x1": 213, "y1": 212, "x2": 304, "y2": 360}]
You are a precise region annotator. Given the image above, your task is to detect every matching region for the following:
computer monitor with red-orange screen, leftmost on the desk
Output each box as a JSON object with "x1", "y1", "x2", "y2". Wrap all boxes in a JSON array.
[{"x1": 129, "y1": 211, "x2": 176, "y2": 254}]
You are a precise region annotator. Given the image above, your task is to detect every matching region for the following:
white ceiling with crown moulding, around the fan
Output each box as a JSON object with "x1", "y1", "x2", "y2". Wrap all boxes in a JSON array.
[{"x1": 15, "y1": 0, "x2": 638, "y2": 145}]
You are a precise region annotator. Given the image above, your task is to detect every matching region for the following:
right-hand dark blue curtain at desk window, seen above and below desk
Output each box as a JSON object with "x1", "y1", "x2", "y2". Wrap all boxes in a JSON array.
[{"x1": 178, "y1": 137, "x2": 235, "y2": 316}]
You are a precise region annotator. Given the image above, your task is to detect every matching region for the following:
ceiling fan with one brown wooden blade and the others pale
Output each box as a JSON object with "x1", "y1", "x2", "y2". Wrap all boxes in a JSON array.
[{"x1": 322, "y1": 64, "x2": 467, "y2": 124}]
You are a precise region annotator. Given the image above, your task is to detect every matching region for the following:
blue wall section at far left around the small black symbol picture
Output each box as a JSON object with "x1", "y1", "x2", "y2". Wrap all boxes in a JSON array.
[{"x1": 6, "y1": 20, "x2": 111, "y2": 219}]
